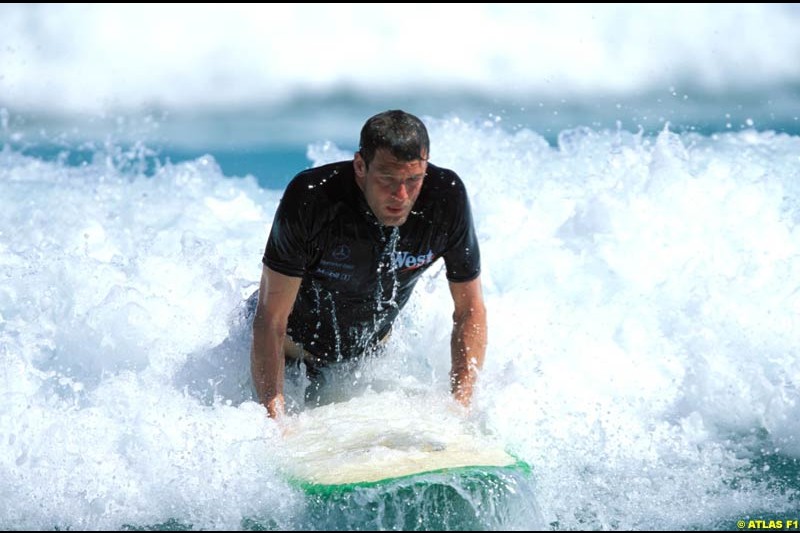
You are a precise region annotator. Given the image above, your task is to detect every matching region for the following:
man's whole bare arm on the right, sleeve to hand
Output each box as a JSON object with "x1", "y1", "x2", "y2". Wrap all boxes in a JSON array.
[{"x1": 450, "y1": 276, "x2": 486, "y2": 407}]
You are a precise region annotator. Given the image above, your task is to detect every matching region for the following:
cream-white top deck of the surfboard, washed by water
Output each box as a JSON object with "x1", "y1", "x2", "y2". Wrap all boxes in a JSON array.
[{"x1": 284, "y1": 392, "x2": 519, "y2": 485}]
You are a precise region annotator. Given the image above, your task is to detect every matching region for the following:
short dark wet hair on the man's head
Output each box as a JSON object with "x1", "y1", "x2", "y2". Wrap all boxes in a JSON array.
[{"x1": 358, "y1": 109, "x2": 431, "y2": 167}]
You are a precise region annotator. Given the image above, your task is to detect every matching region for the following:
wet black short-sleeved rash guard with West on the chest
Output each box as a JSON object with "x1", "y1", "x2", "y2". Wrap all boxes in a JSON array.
[{"x1": 263, "y1": 161, "x2": 480, "y2": 363}]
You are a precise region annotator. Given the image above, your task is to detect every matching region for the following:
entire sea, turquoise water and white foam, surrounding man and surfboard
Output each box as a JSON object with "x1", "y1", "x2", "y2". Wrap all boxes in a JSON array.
[{"x1": 0, "y1": 4, "x2": 800, "y2": 530}]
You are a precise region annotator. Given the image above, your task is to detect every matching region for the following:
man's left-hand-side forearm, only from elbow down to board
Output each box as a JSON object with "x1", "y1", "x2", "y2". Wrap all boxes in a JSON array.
[{"x1": 250, "y1": 317, "x2": 286, "y2": 418}]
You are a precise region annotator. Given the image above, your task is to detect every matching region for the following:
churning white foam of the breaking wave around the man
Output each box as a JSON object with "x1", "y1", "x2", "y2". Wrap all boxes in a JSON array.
[{"x1": 0, "y1": 119, "x2": 800, "y2": 529}]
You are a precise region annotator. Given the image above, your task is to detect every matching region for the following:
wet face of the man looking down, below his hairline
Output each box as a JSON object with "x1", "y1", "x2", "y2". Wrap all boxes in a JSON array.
[{"x1": 353, "y1": 149, "x2": 428, "y2": 226}]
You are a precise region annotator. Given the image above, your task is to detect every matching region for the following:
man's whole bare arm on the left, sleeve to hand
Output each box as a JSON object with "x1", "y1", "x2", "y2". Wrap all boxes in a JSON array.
[{"x1": 250, "y1": 266, "x2": 302, "y2": 418}]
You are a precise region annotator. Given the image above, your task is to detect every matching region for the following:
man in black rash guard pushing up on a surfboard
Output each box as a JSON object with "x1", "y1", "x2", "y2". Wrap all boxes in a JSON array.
[{"x1": 251, "y1": 111, "x2": 486, "y2": 418}]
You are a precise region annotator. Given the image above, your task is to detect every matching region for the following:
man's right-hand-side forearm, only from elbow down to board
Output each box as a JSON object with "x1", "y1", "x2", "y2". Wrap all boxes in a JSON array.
[{"x1": 450, "y1": 306, "x2": 487, "y2": 406}]
